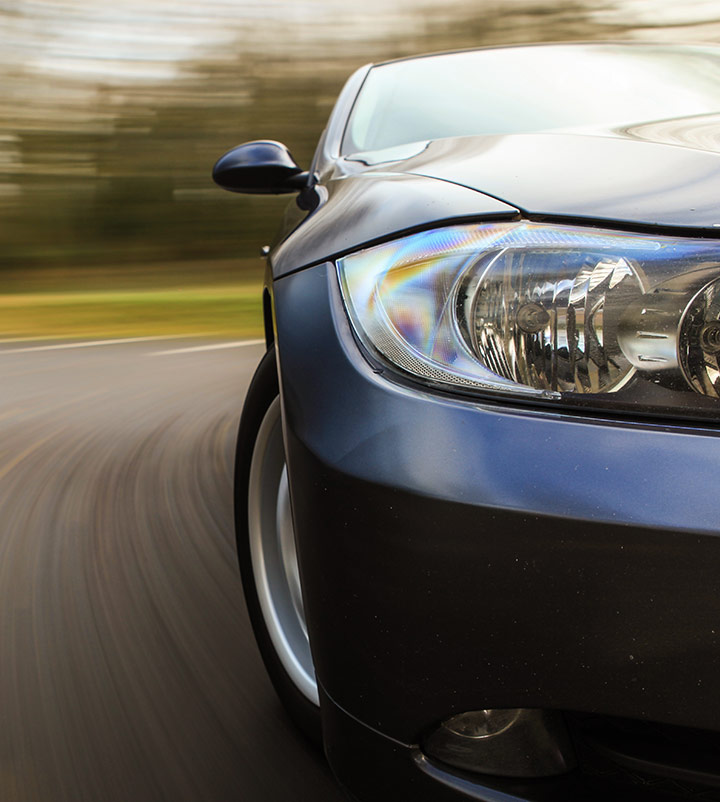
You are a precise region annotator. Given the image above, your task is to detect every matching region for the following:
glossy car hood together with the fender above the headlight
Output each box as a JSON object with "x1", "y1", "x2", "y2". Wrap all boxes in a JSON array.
[{"x1": 271, "y1": 115, "x2": 720, "y2": 278}]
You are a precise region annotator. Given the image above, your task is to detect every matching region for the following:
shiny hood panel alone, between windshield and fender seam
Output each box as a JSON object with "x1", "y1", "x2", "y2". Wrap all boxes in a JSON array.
[{"x1": 350, "y1": 120, "x2": 720, "y2": 232}]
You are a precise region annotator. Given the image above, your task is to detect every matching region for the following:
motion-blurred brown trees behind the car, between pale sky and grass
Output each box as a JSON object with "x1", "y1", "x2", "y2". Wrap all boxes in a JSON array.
[{"x1": 0, "y1": 0, "x2": 623, "y2": 278}]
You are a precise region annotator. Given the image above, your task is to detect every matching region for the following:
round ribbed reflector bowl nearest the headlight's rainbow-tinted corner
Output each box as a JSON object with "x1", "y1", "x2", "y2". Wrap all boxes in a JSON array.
[{"x1": 466, "y1": 249, "x2": 642, "y2": 393}]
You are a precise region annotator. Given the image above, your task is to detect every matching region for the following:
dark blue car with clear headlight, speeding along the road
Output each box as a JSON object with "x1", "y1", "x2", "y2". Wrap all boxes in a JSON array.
[{"x1": 214, "y1": 43, "x2": 720, "y2": 802}]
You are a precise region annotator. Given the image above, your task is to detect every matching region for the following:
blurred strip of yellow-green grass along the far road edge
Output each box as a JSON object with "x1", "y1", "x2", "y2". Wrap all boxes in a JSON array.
[{"x1": 0, "y1": 260, "x2": 263, "y2": 339}]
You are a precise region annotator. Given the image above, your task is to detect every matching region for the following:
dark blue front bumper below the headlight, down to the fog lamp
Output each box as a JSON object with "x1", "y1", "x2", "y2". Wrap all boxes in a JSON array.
[{"x1": 274, "y1": 265, "x2": 720, "y2": 799}]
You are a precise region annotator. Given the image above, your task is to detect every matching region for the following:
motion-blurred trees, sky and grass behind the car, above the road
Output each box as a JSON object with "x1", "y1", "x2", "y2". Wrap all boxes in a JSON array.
[{"x1": 0, "y1": 0, "x2": 720, "y2": 339}]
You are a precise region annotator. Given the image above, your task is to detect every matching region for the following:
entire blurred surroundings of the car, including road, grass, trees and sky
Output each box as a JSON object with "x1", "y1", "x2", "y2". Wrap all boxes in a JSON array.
[{"x1": 7, "y1": 0, "x2": 720, "y2": 802}]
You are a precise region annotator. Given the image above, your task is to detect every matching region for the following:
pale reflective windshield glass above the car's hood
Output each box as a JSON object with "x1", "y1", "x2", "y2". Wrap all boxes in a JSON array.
[{"x1": 342, "y1": 45, "x2": 720, "y2": 155}]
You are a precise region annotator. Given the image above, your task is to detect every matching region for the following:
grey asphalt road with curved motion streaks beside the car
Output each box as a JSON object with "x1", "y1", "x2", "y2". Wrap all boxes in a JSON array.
[{"x1": 0, "y1": 339, "x2": 343, "y2": 802}]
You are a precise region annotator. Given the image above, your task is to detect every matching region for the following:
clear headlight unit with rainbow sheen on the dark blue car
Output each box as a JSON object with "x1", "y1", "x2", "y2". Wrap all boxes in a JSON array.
[{"x1": 338, "y1": 222, "x2": 720, "y2": 416}]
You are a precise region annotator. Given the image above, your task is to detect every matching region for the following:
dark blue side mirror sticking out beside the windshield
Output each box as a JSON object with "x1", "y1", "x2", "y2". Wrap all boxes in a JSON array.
[{"x1": 213, "y1": 140, "x2": 309, "y2": 195}]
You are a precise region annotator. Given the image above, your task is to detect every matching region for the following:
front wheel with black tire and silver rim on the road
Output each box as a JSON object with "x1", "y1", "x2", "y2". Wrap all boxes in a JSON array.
[{"x1": 235, "y1": 347, "x2": 322, "y2": 745}]
